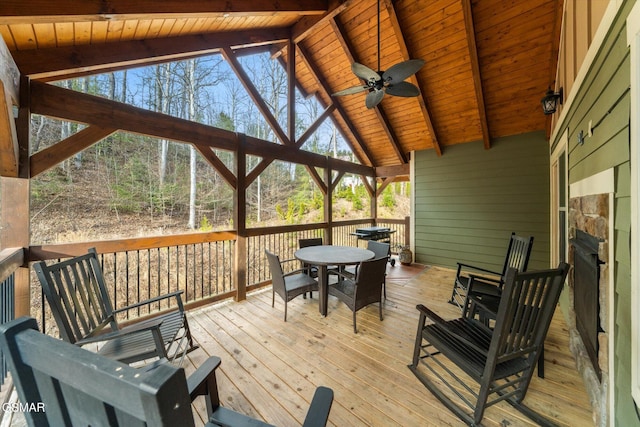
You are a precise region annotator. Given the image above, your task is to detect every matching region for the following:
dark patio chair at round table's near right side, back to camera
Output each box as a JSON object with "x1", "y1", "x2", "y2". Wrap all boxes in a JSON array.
[{"x1": 329, "y1": 257, "x2": 388, "y2": 334}]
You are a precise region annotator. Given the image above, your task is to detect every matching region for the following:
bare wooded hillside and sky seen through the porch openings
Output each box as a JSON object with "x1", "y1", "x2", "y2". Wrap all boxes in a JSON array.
[{"x1": 26, "y1": 53, "x2": 409, "y2": 244}]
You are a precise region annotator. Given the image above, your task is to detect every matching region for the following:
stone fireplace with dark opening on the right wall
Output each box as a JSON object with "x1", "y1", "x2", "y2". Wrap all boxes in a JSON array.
[{"x1": 568, "y1": 193, "x2": 613, "y2": 426}]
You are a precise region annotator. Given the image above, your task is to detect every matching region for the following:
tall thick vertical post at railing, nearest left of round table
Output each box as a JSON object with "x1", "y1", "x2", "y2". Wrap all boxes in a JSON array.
[{"x1": 233, "y1": 134, "x2": 247, "y2": 301}]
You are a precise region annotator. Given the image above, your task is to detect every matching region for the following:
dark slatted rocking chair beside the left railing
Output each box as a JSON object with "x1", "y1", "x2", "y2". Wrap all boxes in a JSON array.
[{"x1": 33, "y1": 248, "x2": 198, "y2": 363}]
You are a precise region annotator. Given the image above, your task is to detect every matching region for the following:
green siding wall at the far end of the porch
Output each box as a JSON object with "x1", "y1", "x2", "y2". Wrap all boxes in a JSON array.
[{"x1": 413, "y1": 132, "x2": 549, "y2": 271}]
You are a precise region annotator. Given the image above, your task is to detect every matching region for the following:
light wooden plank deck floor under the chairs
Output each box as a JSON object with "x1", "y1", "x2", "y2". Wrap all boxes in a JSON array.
[{"x1": 185, "y1": 265, "x2": 593, "y2": 427}]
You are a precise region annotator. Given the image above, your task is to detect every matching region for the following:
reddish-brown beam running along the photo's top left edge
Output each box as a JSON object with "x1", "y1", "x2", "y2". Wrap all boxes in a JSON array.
[{"x1": 0, "y1": 0, "x2": 327, "y2": 24}]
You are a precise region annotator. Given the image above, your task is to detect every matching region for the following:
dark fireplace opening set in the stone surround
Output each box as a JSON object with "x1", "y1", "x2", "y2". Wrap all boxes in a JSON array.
[{"x1": 571, "y1": 230, "x2": 603, "y2": 381}]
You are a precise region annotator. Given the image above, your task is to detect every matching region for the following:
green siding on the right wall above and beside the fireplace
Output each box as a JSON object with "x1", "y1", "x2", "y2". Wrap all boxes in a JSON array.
[{"x1": 555, "y1": 0, "x2": 640, "y2": 426}]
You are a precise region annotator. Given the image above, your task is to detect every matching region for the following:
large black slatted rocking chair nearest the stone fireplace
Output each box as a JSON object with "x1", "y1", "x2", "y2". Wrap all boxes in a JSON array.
[{"x1": 409, "y1": 263, "x2": 569, "y2": 425}]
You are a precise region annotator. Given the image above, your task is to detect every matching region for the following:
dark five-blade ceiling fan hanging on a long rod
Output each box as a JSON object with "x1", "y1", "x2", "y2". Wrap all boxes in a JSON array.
[{"x1": 333, "y1": 0, "x2": 425, "y2": 108}]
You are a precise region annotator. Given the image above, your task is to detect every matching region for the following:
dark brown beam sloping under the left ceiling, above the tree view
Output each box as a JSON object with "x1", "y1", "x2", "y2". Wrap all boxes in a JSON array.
[{"x1": 13, "y1": 28, "x2": 289, "y2": 81}]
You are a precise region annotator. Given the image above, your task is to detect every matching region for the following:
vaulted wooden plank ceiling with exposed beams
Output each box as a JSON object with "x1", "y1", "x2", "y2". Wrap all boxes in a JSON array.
[{"x1": 0, "y1": 0, "x2": 563, "y2": 171}]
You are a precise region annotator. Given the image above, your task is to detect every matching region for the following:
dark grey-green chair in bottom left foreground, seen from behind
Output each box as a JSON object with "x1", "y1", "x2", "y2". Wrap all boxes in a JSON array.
[{"x1": 0, "y1": 317, "x2": 333, "y2": 427}]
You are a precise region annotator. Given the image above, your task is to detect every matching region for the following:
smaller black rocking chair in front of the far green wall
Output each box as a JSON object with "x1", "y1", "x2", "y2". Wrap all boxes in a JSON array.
[{"x1": 449, "y1": 233, "x2": 533, "y2": 316}]
